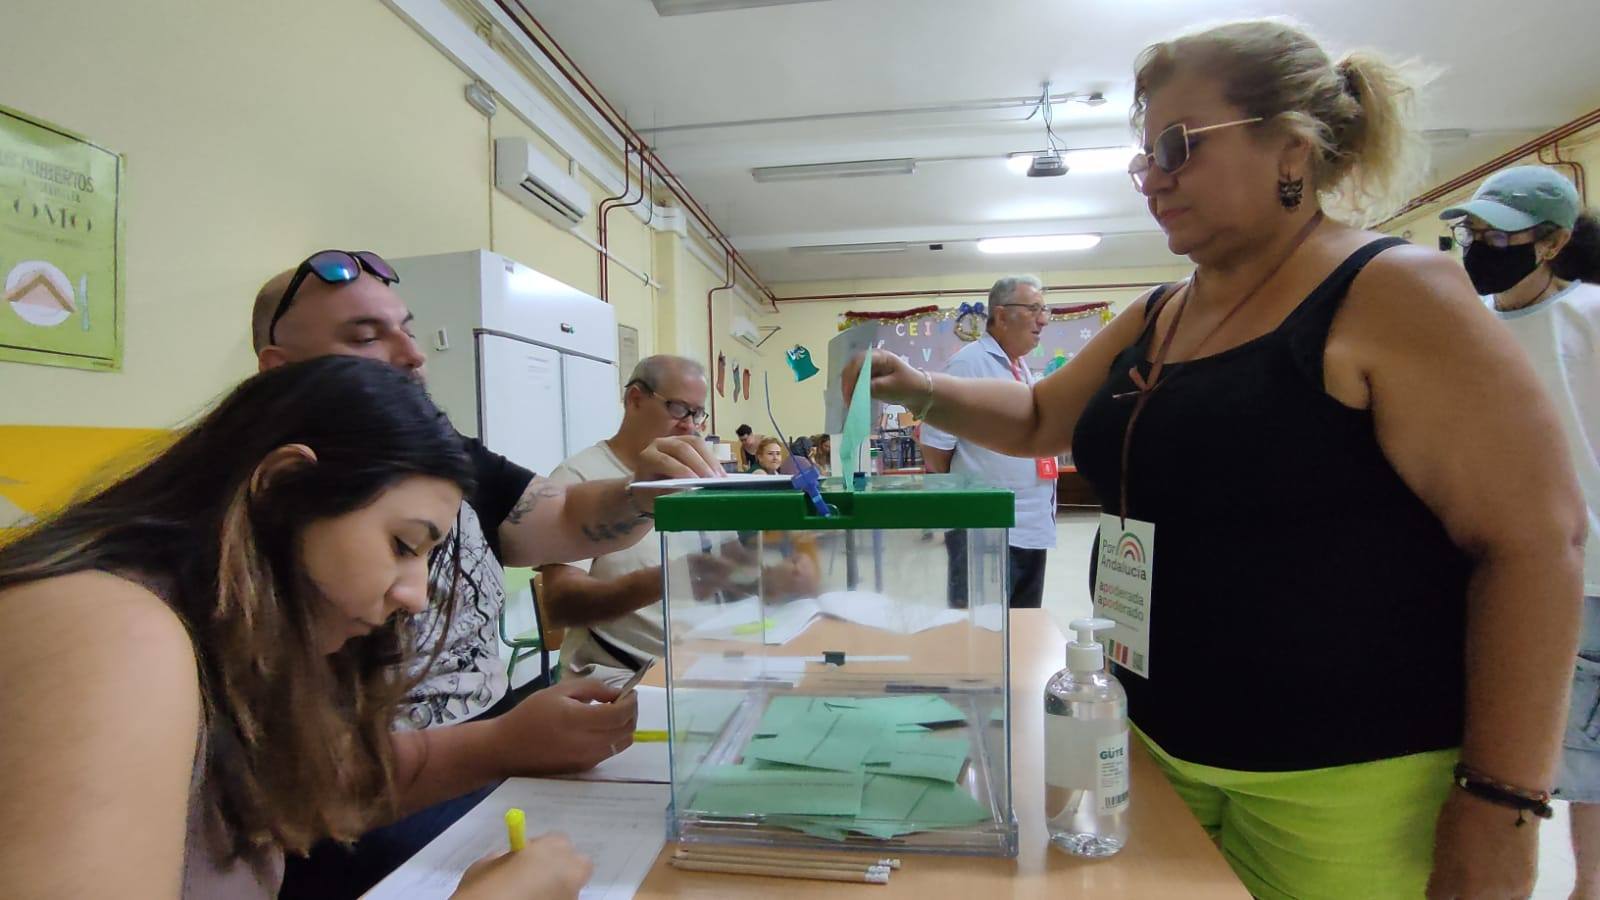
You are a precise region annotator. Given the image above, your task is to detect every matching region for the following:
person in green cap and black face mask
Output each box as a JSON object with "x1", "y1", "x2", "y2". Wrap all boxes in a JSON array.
[{"x1": 1440, "y1": 165, "x2": 1600, "y2": 900}]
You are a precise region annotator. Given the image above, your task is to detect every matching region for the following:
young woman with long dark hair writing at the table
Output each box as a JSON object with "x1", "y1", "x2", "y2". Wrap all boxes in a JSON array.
[{"x1": 0, "y1": 357, "x2": 589, "y2": 900}]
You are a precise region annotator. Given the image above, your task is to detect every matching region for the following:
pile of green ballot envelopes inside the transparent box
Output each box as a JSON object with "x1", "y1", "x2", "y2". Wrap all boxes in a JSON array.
[{"x1": 688, "y1": 695, "x2": 990, "y2": 841}]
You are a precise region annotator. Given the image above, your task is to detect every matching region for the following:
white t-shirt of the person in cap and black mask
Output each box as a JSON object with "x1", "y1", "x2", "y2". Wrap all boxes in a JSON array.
[{"x1": 1488, "y1": 282, "x2": 1600, "y2": 597}]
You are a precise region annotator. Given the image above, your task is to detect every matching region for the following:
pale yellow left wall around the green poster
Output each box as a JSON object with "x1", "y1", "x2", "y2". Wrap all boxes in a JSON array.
[{"x1": 0, "y1": 0, "x2": 675, "y2": 428}]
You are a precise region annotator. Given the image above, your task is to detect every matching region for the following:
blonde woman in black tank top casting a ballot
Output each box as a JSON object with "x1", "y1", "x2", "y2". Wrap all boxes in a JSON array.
[{"x1": 843, "y1": 21, "x2": 1584, "y2": 900}]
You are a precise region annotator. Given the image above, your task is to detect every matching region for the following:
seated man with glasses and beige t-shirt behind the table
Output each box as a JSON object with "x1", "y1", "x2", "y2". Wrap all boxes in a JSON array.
[{"x1": 539, "y1": 356, "x2": 707, "y2": 681}]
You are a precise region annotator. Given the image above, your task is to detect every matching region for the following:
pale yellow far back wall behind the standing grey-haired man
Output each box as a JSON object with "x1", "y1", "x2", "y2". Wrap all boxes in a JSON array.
[{"x1": 758, "y1": 264, "x2": 1189, "y2": 439}]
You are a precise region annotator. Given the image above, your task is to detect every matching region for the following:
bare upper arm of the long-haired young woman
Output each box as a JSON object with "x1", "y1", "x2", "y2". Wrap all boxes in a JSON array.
[{"x1": 0, "y1": 572, "x2": 200, "y2": 900}]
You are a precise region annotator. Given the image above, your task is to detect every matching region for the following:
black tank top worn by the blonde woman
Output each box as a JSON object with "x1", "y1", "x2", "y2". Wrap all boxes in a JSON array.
[{"x1": 1072, "y1": 239, "x2": 1470, "y2": 772}]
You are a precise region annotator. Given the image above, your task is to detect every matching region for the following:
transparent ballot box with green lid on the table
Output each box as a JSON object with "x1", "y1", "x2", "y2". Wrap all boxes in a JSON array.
[{"x1": 656, "y1": 476, "x2": 1016, "y2": 857}]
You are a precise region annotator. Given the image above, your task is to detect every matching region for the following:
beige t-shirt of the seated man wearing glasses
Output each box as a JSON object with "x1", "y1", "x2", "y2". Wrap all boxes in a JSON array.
[{"x1": 550, "y1": 440, "x2": 666, "y2": 669}]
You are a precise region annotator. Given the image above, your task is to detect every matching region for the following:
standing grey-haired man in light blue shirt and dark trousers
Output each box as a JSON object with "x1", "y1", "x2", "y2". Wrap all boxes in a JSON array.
[{"x1": 920, "y1": 275, "x2": 1056, "y2": 609}]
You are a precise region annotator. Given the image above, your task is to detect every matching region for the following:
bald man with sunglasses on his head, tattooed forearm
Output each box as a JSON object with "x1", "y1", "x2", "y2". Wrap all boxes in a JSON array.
[{"x1": 251, "y1": 250, "x2": 720, "y2": 897}]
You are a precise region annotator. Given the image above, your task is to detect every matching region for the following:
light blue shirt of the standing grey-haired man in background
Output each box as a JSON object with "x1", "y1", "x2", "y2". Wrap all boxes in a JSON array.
[{"x1": 922, "y1": 335, "x2": 1056, "y2": 549}]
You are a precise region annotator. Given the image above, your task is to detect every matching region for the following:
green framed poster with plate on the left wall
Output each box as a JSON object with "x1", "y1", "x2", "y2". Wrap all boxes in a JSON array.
[{"x1": 0, "y1": 106, "x2": 125, "y2": 372}]
